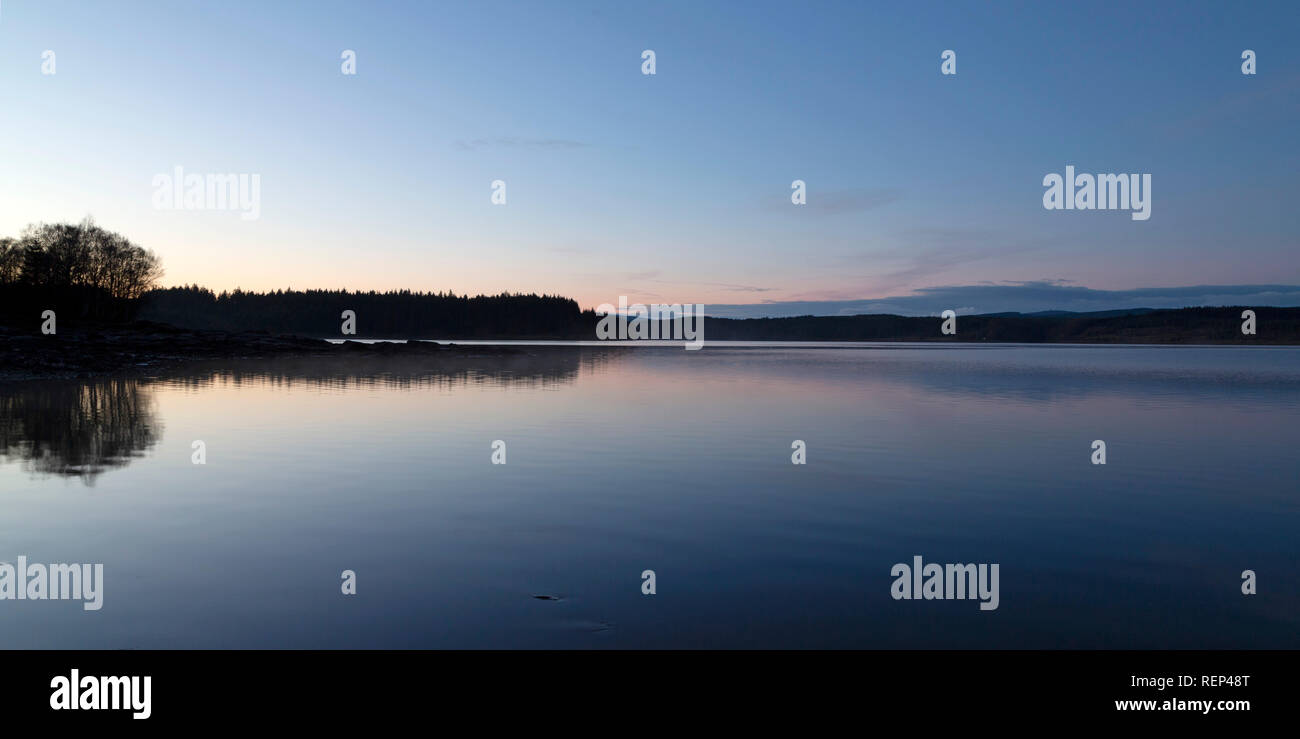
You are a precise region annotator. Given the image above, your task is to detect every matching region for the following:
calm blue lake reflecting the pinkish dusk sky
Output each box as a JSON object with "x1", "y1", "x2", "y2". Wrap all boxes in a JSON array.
[{"x1": 0, "y1": 342, "x2": 1300, "y2": 649}]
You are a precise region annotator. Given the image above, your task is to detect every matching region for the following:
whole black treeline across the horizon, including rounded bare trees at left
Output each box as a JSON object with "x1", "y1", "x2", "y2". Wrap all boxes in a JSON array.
[{"x1": 0, "y1": 217, "x2": 1300, "y2": 343}]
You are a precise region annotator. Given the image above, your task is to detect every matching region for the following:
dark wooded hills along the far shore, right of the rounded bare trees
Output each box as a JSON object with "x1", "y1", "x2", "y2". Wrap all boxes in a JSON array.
[{"x1": 131, "y1": 288, "x2": 1300, "y2": 343}]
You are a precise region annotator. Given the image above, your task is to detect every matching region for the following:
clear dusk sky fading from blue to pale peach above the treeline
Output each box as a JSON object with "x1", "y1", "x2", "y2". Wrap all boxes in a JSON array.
[{"x1": 0, "y1": 0, "x2": 1300, "y2": 315}]
